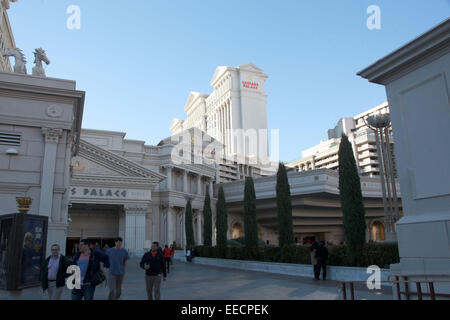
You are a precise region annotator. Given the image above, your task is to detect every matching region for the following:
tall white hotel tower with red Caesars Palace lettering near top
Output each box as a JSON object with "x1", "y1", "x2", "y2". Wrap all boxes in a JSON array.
[{"x1": 170, "y1": 63, "x2": 268, "y2": 163}]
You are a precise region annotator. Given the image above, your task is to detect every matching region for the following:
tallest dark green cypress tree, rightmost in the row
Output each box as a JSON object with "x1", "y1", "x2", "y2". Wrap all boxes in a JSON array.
[{"x1": 339, "y1": 134, "x2": 366, "y2": 265}]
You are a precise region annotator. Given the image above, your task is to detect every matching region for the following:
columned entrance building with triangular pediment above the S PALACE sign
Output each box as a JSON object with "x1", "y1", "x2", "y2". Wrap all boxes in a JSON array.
[{"x1": 67, "y1": 129, "x2": 217, "y2": 256}]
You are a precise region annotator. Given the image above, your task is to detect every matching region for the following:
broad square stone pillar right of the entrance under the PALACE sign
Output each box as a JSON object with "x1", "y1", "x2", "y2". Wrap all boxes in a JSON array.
[{"x1": 125, "y1": 204, "x2": 147, "y2": 256}]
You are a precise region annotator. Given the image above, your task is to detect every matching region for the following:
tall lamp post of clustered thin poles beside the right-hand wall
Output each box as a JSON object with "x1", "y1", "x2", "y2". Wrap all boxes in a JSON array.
[{"x1": 364, "y1": 114, "x2": 400, "y2": 241}]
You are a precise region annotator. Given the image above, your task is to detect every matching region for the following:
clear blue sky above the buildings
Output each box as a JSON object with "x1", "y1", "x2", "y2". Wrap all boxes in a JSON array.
[{"x1": 9, "y1": 0, "x2": 450, "y2": 161}]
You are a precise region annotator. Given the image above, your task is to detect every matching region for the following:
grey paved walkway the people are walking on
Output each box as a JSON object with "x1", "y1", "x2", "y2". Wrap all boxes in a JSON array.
[{"x1": 0, "y1": 259, "x2": 392, "y2": 300}]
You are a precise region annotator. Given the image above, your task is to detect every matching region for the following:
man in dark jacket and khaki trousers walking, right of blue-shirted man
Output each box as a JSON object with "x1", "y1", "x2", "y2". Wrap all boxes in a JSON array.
[{"x1": 140, "y1": 242, "x2": 167, "y2": 300}]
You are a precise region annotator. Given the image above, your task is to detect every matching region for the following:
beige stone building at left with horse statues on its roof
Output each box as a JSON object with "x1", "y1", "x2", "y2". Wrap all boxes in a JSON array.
[{"x1": 0, "y1": 72, "x2": 85, "y2": 252}]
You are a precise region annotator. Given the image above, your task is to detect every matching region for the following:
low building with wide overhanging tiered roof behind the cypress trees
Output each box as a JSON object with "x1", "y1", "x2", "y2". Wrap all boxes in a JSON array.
[{"x1": 222, "y1": 169, "x2": 401, "y2": 245}]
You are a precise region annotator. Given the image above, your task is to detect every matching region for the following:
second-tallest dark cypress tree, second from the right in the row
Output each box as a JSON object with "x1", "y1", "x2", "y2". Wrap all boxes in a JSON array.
[{"x1": 277, "y1": 162, "x2": 295, "y2": 247}]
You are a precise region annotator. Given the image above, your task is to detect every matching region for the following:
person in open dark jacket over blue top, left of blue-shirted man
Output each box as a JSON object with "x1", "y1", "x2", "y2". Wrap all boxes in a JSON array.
[{"x1": 72, "y1": 239, "x2": 109, "y2": 300}]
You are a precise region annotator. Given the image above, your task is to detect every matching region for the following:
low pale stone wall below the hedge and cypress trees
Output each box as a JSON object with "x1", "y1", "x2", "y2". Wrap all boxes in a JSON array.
[{"x1": 175, "y1": 251, "x2": 390, "y2": 286}]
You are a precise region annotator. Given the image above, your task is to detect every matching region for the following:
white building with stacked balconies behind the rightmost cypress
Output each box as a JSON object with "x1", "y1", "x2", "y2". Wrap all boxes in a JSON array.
[{"x1": 287, "y1": 102, "x2": 395, "y2": 177}]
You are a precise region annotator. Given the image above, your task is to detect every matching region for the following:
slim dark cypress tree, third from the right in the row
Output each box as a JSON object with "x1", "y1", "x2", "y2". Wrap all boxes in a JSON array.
[{"x1": 244, "y1": 177, "x2": 258, "y2": 249}]
